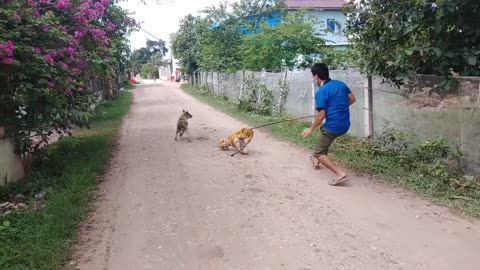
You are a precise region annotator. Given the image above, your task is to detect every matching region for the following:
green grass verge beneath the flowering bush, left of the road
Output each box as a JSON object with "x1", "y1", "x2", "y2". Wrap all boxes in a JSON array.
[{"x1": 0, "y1": 91, "x2": 132, "y2": 270}]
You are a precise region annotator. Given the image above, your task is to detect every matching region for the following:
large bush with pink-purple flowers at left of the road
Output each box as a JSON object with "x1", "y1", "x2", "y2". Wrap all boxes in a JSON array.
[{"x1": 0, "y1": 0, "x2": 138, "y2": 171}]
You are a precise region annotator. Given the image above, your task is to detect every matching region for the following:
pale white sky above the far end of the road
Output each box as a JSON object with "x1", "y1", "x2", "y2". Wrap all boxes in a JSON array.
[{"x1": 120, "y1": 0, "x2": 234, "y2": 53}]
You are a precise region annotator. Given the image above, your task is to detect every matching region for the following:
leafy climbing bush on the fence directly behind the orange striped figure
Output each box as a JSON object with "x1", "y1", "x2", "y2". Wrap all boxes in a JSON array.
[{"x1": 234, "y1": 76, "x2": 273, "y2": 115}]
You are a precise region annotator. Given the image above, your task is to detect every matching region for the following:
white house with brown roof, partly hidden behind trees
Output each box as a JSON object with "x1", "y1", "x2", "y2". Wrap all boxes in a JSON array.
[{"x1": 285, "y1": 0, "x2": 349, "y2": 49}]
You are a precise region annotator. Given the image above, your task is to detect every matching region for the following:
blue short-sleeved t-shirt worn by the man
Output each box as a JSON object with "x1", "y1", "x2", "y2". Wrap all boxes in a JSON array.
[{"x1": 315, "y1": 80, "x2": 351, "y2": 136}]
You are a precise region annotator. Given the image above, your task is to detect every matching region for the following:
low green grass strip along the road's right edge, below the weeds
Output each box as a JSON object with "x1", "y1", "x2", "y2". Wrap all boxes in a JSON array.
[{"x1": 182, "y1": 84, "x2": 480, "y2": 218}]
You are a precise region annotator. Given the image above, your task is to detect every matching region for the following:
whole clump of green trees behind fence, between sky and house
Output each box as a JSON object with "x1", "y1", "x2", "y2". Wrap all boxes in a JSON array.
[{"x1": 171, "y1": 0, "x2": 334, "y2": 74}]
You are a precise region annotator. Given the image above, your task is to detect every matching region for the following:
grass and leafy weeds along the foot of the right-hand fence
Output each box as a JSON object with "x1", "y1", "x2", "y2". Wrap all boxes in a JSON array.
[{"x1": 182, "y1": 84, "x2": 480, "y2": 218}]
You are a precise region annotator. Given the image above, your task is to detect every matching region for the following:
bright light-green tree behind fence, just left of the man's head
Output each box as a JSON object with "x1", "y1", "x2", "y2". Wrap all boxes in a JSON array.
[{"x1": 240, "y1": 12, "x2": 325, "y2": 70}]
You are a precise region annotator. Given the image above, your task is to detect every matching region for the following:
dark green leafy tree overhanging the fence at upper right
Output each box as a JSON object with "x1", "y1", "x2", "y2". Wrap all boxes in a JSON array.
[{"x1": 346, "y1": 0, "x2": 480, "y2": 87}]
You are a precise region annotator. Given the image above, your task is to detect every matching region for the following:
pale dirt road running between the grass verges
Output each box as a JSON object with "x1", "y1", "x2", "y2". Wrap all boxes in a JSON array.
[{"x1": 69, "y1": 83, "x2": 480, "y2": 270}]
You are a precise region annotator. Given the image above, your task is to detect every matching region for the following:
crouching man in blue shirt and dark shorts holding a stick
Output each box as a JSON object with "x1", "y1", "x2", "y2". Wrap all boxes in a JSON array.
[{"x1": 303, "y1": 64, "x2": 356, "y2": 186}]
